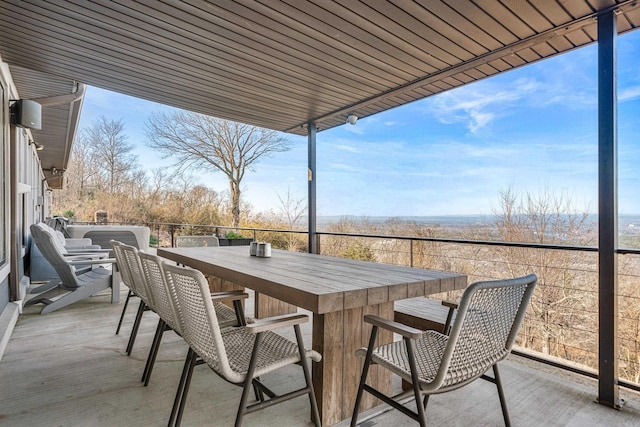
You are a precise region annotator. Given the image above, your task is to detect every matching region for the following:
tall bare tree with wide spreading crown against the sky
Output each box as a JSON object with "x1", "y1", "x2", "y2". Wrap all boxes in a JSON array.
[{"x1": 146, "y1": 111, "x2": 290, "y2": 227}]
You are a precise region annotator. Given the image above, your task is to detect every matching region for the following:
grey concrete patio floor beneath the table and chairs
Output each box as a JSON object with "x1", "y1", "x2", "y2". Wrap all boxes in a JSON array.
[{"x1": 0, "y1": 293, "x2": 640, "y2": 427}]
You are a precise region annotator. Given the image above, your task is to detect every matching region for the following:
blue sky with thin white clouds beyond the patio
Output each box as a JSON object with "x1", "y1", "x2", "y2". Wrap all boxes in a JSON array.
[{"x1": 80, "y1": 31, "x2": 640, "y2": 216}]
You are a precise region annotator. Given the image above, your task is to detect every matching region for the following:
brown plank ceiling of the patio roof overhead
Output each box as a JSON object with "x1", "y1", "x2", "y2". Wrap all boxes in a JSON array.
[{"x1": 0, "y1": 0, "x2": 640, "y2": 181}]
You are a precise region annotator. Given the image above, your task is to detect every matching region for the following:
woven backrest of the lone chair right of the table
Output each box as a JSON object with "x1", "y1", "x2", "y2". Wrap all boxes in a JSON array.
[{"x1": 434, "y1": 274, "x2": 537, "y2": 387}]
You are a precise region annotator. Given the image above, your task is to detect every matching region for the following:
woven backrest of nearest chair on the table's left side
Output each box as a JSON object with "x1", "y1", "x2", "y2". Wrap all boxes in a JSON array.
[{"x1": 162, "y1": 263, "x2": 230, "y2": 377}]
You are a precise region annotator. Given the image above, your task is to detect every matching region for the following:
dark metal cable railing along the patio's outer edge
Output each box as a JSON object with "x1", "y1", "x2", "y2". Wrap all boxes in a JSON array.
[{"x1": 71, "y1": 223, "x2": 640, "y2": 390}]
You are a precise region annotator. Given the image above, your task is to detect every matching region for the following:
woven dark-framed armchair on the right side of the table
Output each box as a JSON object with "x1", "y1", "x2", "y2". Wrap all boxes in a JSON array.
[{"x1": 351, "y1": 274, "x2": 537, "y2": 427}]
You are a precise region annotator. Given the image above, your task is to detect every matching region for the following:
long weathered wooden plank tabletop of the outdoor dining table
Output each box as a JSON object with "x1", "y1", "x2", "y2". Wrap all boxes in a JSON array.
[{"x1": 158, "y1": 246, "x2": 467, "y2": 314}]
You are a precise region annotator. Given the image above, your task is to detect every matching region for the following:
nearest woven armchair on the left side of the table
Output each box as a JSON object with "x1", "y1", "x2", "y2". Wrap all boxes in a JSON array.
[{"x1": 163, "y1": 264, "x2": 321, "y2": 427}]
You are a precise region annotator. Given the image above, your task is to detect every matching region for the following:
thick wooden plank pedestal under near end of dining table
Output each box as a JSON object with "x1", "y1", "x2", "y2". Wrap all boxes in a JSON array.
[{"x1": 313, "y1": 302, "x2": 393, "y2": 426}]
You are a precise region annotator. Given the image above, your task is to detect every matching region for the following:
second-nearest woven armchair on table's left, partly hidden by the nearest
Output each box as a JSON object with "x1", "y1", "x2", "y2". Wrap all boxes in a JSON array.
[{"x1": 137, "y1": 251, "x2": 253, "y2": 386}]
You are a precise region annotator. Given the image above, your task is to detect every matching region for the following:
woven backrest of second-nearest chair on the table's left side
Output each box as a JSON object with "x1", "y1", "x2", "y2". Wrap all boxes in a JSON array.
[{"x1": 138, "y1": 251, "x2": 182, "y2": 335}]
